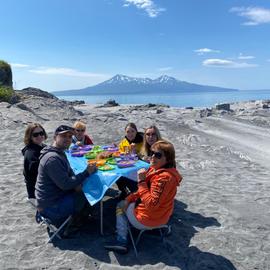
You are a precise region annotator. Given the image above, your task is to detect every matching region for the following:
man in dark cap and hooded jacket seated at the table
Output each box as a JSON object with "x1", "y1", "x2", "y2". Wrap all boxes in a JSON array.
[{"x1": 35, "y1": 125, "x2": 96, "y2": 231}]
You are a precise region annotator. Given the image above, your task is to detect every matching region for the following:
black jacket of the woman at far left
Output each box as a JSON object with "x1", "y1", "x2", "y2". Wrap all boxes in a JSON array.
[{"x1": 22, "y1": 143, "x2": 45, "y2": 183}]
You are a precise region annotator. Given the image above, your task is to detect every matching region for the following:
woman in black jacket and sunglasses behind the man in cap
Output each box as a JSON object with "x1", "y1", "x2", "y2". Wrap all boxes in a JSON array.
[{"x1": 22, "y1": 123, "x2": 47, "y2": 199}]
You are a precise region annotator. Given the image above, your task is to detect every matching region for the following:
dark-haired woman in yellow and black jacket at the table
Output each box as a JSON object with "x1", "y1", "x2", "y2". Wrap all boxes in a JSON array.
[{"x1": 119, "y1": 123, "x2": 143, "y2": 154}]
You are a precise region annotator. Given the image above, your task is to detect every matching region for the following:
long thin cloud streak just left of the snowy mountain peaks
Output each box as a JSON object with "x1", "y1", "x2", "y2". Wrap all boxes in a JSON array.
[{"x1": 29, "y1": 67, "x2": 106, "y2": 78}]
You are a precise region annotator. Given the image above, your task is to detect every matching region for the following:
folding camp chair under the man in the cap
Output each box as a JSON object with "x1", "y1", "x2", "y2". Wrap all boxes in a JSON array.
[{"x1": 28, "y1": 199, "x2": 72, "y2": 243}]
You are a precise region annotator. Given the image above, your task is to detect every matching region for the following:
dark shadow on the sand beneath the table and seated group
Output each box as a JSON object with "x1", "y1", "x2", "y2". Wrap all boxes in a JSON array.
[{"x1": 54, "y1": 199, "x2": 236, "y2": 270}]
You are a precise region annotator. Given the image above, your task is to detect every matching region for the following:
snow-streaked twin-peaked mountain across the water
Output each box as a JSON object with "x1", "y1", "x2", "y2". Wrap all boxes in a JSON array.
[{"x1": 53, "y1": 74, "x2": 238, "y2": 96}]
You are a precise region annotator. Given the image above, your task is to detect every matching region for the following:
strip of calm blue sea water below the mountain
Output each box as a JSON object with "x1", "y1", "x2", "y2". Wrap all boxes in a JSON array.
[{"x1": 58, "y1": 90, "x2": 270, "y2": 107}]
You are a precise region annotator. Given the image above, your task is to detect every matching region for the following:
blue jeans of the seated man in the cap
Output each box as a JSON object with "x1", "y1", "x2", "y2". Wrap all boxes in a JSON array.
[{"x1": 41, "y1": 194, "x2": 75, "y2": 226}]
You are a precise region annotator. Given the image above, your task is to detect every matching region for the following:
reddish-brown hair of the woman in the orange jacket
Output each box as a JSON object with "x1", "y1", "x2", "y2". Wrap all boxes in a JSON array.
[{"x1": 151, "y1": 140, "x2": 176, "y2": 168}]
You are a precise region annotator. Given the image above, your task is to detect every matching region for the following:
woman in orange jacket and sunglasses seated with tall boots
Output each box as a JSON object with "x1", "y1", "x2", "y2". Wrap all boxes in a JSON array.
[{"x1": 105, "y1": 140, "x2": 182, "y2": 254}]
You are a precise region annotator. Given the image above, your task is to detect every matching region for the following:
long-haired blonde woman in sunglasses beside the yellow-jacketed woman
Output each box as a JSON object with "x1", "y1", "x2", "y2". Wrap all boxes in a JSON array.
[{"x1": 139, "y1": 126, "x2": 161, "y2": 162}]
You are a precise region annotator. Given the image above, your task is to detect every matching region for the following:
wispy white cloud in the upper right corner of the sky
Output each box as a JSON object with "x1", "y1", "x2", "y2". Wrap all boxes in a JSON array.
[{"x1": 230, "y1": 7, "x2": 270, "y2": 25}]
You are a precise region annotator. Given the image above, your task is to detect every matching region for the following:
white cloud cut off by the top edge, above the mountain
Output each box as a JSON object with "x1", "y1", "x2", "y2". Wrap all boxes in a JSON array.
[{"x1": 124, "y1": 0, "x2": 166, "y2": 18}]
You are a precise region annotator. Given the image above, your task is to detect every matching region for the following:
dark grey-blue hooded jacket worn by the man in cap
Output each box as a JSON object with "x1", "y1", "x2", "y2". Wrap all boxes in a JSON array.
[{"x1": 36, "y1": 146, "x2": 89, "y2": 208}]
